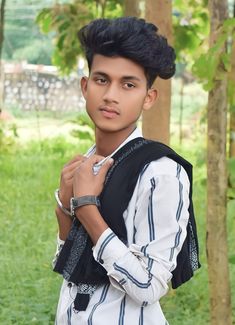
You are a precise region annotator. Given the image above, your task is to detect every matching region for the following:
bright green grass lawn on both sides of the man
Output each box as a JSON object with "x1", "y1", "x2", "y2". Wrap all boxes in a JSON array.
[{"x1": 0, "y1": 130, "x2": 235, "y2": 325}]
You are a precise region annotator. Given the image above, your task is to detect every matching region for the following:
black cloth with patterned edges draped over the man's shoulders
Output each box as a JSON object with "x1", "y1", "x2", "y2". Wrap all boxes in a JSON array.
[{"x1": 54, "y1": 138, "x2": 200, "y2": 288}]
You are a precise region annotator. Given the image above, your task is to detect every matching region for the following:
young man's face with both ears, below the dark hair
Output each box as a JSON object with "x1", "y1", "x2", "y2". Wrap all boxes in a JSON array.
[{"x1": 81, "y1": 54, "x2": 156, "y2": 135}]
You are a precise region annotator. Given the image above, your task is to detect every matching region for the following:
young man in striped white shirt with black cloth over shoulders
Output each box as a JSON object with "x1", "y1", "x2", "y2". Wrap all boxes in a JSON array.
[{"x1": 54, "y1": 17, "x2": 199, "y2": 325}]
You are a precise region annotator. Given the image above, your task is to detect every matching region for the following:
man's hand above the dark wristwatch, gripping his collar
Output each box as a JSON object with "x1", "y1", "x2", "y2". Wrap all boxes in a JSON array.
[{"x1": 73, "y1": 155, "x2": 113, "y2": 197}]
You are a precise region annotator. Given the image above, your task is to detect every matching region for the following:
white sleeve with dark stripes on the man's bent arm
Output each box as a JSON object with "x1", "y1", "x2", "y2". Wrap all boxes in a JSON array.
[{"x1": 93, "y1": 158, "x2": 190, "y2": 305}]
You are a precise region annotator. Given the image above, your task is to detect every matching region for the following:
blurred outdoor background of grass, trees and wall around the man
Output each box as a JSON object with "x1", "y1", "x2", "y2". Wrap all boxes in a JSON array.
[{"x1": 0, "y1": 0, "x2": 235, "y2": 325}]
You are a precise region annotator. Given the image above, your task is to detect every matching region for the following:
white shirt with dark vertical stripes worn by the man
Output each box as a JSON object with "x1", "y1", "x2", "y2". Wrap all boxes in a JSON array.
[{"x1": 56, "y1": 130, "x2": 190, "y2": 325}]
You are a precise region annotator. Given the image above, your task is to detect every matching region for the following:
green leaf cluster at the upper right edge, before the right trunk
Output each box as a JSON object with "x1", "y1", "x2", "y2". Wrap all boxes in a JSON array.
[{"x1": 193, "y1": 18, "x2": 235, "y2": 94}]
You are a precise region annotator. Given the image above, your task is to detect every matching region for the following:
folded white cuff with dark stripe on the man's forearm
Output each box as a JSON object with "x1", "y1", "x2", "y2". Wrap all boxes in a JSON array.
[{"x1": 93, "y1": 228, "x2": 128, "y2": 273}]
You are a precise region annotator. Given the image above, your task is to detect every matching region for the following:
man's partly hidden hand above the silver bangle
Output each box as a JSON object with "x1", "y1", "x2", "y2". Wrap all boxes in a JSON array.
[{"x1": 59, "y1": 155, "x2": 87, "y2": 209}]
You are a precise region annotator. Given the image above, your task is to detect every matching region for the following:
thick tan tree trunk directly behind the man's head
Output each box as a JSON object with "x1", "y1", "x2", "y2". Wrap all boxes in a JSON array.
[{"x1": 142, "y1": 0, "x2": 172, "y2": 144}]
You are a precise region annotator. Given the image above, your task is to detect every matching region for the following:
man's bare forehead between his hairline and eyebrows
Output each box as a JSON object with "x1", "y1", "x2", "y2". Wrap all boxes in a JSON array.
[{"x1": 90, "y1": 54, "x2": 146, "y2": 82}]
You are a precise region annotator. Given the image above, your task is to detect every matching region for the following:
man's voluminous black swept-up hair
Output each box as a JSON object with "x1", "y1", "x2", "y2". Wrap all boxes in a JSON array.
[{"x1": 78, "y1": 17, "x2": 175, "y2": 88}]
